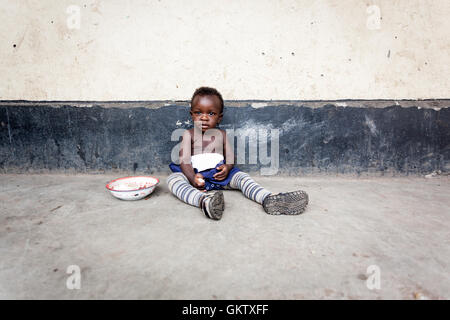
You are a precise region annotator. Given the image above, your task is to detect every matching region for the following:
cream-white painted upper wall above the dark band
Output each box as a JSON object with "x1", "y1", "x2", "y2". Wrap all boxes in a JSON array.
[{"x1": 0, "y1": 0, "x2": 450, "y2": 100}]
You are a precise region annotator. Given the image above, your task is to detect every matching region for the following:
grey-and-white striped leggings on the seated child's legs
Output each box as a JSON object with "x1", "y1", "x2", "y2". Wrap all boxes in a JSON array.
[{"x1": 167, "y1": 171, "x2": 271, "y2": 207}]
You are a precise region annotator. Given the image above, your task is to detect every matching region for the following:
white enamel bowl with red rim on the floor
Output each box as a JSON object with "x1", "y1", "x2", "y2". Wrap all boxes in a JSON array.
[{"x1": 106, "y1": 176, "x2": 159, "y2": 200}]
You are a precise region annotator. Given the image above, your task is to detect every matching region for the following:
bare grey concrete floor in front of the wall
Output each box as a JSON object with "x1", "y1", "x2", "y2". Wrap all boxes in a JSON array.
[{"x1": 0, "y1": 175, "x2": 450, "y2": 299}]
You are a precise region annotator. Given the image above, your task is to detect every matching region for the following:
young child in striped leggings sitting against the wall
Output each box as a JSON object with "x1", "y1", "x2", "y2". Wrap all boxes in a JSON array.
[{"x1": 167, "y1": 87, "x2": 308, "y2": 220}]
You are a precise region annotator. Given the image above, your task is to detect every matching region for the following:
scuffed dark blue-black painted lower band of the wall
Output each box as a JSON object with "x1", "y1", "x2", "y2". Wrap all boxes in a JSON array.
[{"x1": 0, "y1": 103, "x2": 450, "y2": 175}]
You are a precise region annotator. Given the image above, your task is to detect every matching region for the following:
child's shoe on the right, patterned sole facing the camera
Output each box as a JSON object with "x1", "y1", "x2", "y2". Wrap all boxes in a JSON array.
[{"x1": 263, "y1": 190, "x2": 309, "y2": 215}]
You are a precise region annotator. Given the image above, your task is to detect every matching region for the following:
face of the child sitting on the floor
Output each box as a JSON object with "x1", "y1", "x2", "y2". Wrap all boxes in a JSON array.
[{"x1": 190, "y1": 96, "x2": 223, "y2": 132}]
